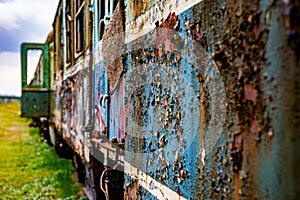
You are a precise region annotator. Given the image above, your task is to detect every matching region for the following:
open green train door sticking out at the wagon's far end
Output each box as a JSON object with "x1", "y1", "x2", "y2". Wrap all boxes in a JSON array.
[{"x1": 21, "y1": 43, "x2": 51, "y2": 118}]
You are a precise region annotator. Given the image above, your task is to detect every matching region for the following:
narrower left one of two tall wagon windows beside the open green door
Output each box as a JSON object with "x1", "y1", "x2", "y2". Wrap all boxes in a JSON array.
[{"x1": 66, "y1": 1, "x2": 72, "y2": 63}]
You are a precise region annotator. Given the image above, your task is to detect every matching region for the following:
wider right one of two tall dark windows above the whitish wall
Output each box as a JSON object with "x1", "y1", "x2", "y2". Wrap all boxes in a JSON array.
[{"x1": 75, "y1": 0, "x2": 85, "y2": 53}]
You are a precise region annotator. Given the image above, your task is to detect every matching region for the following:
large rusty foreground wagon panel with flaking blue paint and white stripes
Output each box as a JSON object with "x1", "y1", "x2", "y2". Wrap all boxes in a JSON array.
[{"x1": 124, "y1": 1, "x2": 299, "y2": 199}]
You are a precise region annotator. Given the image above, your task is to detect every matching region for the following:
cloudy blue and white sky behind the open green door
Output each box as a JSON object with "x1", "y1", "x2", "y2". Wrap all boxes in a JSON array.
[{"x1": 0, "y1": 0, "x2": 59, "y2": 96}]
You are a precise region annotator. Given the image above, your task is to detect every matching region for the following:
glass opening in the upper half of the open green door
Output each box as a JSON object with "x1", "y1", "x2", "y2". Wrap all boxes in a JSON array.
[{"x1": 27, "y1": 49, "x2": 43, "y2": 86}]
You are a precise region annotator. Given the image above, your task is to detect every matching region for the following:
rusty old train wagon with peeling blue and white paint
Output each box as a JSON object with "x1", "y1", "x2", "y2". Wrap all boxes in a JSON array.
[{"x1": 21, "y1": 0, "x2": 300, "y2": 199}]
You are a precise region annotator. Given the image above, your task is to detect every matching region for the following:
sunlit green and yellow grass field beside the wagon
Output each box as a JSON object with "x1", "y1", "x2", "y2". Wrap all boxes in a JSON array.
[{"x1": 0, "y1": 101, "x2": 86, "y2": 199}]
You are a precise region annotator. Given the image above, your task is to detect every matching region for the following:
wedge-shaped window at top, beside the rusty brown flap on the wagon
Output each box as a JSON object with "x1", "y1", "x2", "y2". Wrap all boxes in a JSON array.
[{"x1": 98, "y1": 0, "x2": 118, "y2": 40}]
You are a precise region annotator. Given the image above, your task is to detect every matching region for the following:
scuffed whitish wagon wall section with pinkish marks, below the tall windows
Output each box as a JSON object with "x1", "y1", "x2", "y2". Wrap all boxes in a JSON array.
[{"x1": 61, "y1": 64, "x2": 92, "y2": 162}]
